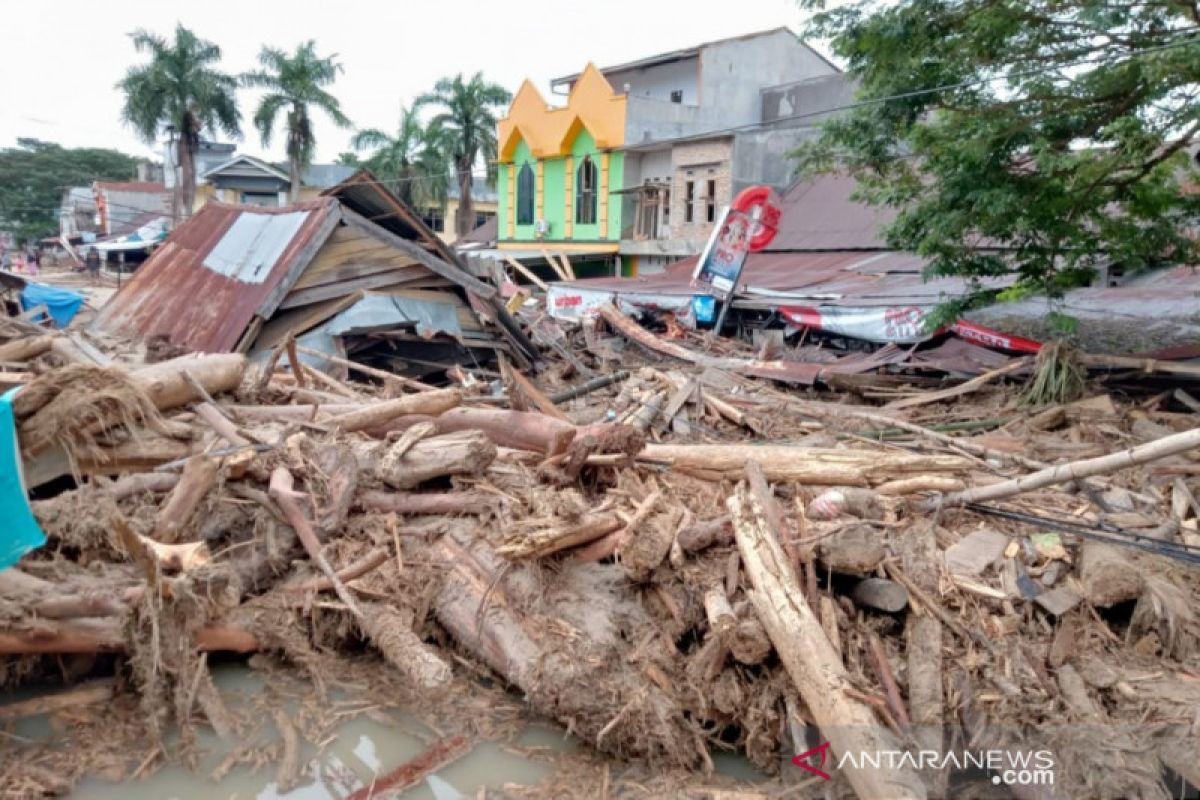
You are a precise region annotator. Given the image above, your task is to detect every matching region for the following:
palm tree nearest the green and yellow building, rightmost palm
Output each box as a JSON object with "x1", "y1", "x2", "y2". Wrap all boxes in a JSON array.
[{"x1": 415, "y1": 72, "x2": 512, "y2": 236}]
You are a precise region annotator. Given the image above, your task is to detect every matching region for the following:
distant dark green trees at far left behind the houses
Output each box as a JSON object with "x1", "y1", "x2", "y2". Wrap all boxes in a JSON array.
[{"x1": 0, "y1": 139, "x2": 138, "y2": 241}]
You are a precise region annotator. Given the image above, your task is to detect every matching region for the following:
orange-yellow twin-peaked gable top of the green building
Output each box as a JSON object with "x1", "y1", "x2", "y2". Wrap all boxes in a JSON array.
[{"x1": 497, "y1": 64, "x2": 625, "y2": 162}]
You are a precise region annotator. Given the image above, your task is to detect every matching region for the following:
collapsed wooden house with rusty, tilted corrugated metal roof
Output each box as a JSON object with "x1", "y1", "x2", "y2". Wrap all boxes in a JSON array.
[{"x1": 92, "y1": 170, "x2": 530, "y2": 378}]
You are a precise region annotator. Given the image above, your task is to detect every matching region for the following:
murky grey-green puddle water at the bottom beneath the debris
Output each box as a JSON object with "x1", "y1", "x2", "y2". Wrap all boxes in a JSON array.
[{"x1": 14, "y1": 664, "x2": 764, "y2": 800}]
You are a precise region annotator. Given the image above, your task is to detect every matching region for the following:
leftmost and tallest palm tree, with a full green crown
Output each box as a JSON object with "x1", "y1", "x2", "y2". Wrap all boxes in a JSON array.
[{"x1": 116, "y1": 25, "x2": 241, "y2": 222}]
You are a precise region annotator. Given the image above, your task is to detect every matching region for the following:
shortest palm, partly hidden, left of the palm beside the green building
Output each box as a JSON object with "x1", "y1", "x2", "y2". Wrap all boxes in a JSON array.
[{"x1": 350, "y1": 106, "x2": 450, "y2": 210}]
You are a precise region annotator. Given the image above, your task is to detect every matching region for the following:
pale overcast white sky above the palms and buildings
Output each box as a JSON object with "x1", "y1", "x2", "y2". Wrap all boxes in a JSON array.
[{"x1": 0, "y1": 0, "x2": 825, "y2": 162}]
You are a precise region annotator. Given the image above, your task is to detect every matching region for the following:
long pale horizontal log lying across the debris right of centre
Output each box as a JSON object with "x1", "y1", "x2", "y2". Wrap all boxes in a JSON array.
[{"x1": 640, "y1": 444, "x2": 971, "y2": 486}]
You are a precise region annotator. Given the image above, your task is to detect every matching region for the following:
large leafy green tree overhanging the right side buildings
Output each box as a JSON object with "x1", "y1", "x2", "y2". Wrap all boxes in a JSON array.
[{"x1": 798, "y1": 0, "x2": 1200, "y2": 323}]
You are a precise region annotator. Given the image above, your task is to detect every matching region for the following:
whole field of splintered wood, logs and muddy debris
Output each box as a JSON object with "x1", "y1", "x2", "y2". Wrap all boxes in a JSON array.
[{"x1": 0, "y1": 302, "x2": 1200, "y2": 800}]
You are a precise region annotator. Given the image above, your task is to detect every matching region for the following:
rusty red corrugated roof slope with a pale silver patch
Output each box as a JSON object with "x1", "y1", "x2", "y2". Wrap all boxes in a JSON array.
[{"x1": 92, "y1": 198, "x2": 340, "y2": 353}]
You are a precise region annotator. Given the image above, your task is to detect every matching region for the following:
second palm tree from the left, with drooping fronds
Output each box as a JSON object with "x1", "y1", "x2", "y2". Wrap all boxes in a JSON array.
[{"x1": 241, "y1": 40, "x2": 350, "y2": 203}]
